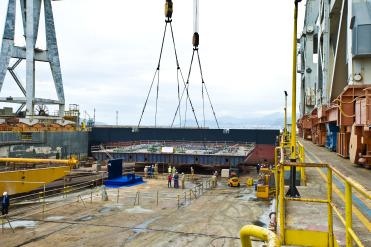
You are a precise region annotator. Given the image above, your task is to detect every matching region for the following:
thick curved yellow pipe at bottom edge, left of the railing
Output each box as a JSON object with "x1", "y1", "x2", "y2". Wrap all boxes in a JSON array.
[{"x1": 240, "y1": 225, "x2": 281, "y2": 247}]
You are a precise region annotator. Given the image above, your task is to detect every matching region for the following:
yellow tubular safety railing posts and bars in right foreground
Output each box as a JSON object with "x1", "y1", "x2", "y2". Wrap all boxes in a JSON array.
[{"x1": 276, "y1": 163, "x2": 371, "y2": 247}]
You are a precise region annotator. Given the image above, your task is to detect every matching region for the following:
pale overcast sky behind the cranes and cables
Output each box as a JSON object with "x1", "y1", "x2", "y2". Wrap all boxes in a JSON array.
[{"x1": 0, "y1": 0, "x2": 304, "y2": 125}]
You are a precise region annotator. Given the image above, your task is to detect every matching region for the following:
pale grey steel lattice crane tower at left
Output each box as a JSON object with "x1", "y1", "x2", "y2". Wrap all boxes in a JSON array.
[{"x1": 0, "y1": 0, "x2": 65, "y2": 117}]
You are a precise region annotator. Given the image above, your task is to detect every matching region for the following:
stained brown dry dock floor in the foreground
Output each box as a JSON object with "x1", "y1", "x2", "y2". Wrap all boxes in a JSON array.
[{"x1": 0, "y1": 172, "x2": 274, "y2": 247}]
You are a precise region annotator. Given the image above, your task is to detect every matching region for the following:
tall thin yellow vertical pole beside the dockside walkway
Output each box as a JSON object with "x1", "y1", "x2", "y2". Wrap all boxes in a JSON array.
[{"x1": 290, "y1": 0, "x2": 298, "y2": 161}]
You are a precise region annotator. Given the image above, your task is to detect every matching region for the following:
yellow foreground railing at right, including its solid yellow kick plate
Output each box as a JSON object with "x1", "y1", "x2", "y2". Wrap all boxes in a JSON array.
[{"x1": 276, "y1": 163, "x2": 371, "y2": 247}]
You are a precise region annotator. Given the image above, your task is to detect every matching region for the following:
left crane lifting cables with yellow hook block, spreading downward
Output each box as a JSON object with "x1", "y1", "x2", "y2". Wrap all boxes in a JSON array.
[{"x1": 137, "y1": 0, "x2": 199, "y2": 128}]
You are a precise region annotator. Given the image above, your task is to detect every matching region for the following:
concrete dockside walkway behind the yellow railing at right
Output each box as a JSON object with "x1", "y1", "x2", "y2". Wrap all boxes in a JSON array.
[{"x1": 286, "y1": 140, "x2": 371, "y2": 246}]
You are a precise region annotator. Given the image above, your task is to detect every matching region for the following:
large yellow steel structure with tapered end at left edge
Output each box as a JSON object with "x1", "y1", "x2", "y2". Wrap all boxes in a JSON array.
[{"x1": 0, "y1": 158, "x2": 78, "y2": 195}]
